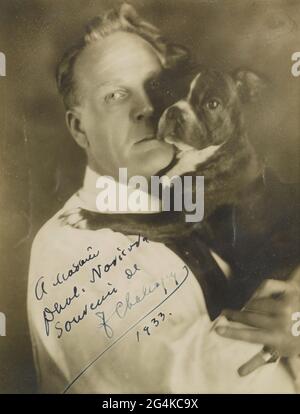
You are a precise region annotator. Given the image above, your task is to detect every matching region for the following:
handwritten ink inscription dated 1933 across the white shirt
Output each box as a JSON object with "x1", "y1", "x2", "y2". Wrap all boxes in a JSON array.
[{"x1": 34, "y1": 235, "x2": 189, "y2": 392}]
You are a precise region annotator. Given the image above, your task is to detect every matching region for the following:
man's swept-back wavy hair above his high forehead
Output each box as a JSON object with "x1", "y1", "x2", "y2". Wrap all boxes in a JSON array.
[{"x1": 56, "y1": 3, "x2": 189, "y2": 109}]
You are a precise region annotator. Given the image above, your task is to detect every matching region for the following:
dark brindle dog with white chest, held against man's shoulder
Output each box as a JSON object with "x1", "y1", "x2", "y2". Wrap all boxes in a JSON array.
[{"x1": 158, "y1": 69, "x2": 300, "y2": 308}]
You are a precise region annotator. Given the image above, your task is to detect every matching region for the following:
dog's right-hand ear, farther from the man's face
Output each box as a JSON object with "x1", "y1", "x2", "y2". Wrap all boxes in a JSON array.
[{"x1": 234, "y1": 70, "x2": 266, "y2": 103}]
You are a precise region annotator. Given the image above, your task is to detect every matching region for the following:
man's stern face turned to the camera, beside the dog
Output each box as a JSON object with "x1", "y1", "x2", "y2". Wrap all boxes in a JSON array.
[{"x1": 75, "y1": 32, "x2": 174, "y2": 177}]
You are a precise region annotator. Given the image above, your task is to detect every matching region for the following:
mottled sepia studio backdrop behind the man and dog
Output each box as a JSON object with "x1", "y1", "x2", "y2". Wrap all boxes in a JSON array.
[{"x1": 0, "y1": 0, "x2": 300, "y2": 393}]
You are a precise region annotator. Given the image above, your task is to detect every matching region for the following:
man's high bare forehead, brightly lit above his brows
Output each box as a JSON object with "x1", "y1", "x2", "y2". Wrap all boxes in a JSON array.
[{"x1": 75, "y1": 32, "x2": 161, "y2": 90}]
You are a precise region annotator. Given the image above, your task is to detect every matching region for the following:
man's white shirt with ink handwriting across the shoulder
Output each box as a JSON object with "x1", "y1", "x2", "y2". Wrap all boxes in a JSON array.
[{"x1": 27, "y1": 169, "x2": 295, "y2": 393}]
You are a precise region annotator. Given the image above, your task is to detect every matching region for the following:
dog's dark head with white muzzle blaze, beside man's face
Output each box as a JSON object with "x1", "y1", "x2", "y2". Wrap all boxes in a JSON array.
[{"x1": 158, "y1": 70, "x2": 264, "y2": 150}]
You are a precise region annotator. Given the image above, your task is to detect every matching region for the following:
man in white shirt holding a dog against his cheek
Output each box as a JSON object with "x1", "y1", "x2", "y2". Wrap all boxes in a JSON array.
[{"x1": 28, "y1": 4, "x2": 294, "y2": 393}]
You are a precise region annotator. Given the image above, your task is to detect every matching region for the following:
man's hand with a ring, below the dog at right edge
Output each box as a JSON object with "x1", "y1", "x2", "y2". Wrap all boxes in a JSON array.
[{"x1": 216, "y1": 267, "x2": 300, "y2": 376}]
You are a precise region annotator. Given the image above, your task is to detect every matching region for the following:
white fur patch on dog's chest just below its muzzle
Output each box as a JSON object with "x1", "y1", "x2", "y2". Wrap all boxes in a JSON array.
[{"x1": 166, "y1": 144, "x2": 223, "y2": 178}]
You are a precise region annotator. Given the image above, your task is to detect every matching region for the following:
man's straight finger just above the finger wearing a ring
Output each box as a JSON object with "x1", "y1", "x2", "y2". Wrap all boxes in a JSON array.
[{"x1": 215, "y1": 326, "x2": 273, "y2": 346}]
